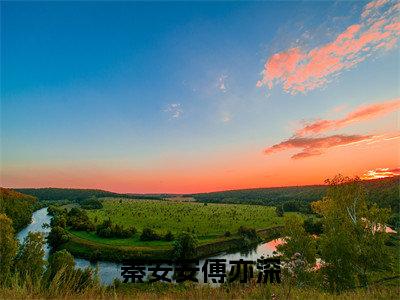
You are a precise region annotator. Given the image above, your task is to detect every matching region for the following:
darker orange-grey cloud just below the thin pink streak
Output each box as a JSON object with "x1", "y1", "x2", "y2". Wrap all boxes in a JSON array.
[{"x1": 264, "y1": 134, "x2": 374, "y2": 159}]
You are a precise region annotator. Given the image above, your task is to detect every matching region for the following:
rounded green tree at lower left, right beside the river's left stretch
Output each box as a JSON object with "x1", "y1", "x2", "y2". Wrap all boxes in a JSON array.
[{"x1": 15, "y1": 232, "x2": 45, "y2": 280}]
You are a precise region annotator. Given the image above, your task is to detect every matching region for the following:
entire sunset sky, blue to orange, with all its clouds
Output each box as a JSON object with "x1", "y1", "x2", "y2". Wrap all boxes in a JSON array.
[{"x1": 0, "y1": 0, "x2": 400, "y2": 193}]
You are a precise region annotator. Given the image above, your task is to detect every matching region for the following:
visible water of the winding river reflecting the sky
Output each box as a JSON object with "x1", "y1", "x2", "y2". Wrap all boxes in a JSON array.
[{"x1": 17, "y1": 208, "x2": 281, "y2": 284}]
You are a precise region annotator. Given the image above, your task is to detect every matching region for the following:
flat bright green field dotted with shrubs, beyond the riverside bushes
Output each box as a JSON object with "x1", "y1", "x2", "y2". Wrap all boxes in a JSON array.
[{"x1": 88, "y1": 198, "x2": 282, "y2": 237}]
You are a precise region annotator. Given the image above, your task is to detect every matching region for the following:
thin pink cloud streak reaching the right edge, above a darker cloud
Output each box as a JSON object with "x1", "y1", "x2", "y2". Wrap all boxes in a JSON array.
[{"x1": 295, "y1": 98, "x2": 400, "y2": 136}]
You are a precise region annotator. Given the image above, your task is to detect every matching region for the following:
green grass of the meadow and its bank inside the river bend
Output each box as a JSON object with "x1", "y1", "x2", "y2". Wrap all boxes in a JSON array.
[{"x1": 63, "y1": 198, "x2": 283, "y2": 261}]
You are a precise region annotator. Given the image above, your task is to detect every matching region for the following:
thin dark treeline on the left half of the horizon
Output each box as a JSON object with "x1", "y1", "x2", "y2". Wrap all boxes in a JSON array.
[{"x1": 15, "y1": 188, "x2": 163, "y2": 203}]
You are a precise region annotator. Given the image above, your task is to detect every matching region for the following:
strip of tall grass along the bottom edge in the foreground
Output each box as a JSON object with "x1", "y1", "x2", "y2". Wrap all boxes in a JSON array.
[{"x1": 0, "y1": 269, "x2": 400, "y2": 300}]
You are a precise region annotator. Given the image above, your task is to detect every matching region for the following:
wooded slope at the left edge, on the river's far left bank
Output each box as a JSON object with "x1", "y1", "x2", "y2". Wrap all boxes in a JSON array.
[{"x1": 0, "y1": 188, "x2": 36, "y2": 231}]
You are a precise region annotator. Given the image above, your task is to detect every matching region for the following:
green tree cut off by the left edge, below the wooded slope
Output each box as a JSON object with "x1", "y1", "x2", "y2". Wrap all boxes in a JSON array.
[{"x1": 0, "y1": 214, "x2": 18, "y2": 284}]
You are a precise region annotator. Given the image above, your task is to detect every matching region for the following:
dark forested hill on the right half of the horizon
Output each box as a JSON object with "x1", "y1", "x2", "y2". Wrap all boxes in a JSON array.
[{"x1": 191, "y1": 176, "x2": 400, "y2": 213}]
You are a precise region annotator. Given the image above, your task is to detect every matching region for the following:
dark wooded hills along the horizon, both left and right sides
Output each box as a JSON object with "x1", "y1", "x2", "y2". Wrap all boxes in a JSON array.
[{"x1": 15, "y1": 176, "x2": 400, "y2": 212}]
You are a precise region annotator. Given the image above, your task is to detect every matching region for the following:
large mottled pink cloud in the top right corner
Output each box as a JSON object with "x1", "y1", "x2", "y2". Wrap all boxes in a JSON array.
[{"x1": 257, "y1": 0, "x2": 400, "y2": 94}]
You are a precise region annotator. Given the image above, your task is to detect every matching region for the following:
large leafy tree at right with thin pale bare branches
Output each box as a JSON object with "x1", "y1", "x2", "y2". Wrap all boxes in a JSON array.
[{"x1": 312, "y1": 175, "x2": 390, "y2": 292}]
